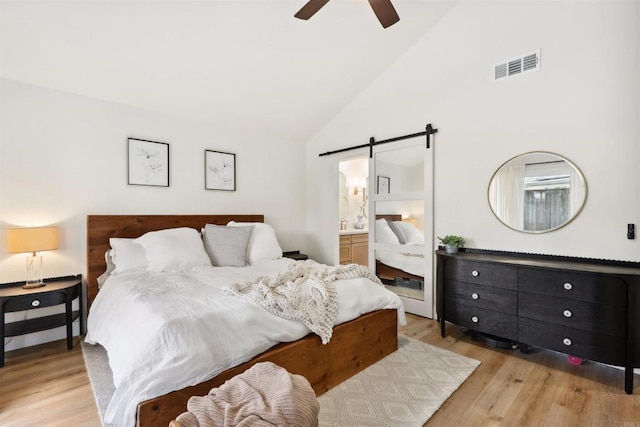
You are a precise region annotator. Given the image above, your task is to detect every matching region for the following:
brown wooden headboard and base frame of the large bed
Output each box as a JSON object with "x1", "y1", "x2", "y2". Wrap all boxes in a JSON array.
[{"x1": 87, "y1": 215, "x2": 398, "y2": 427}]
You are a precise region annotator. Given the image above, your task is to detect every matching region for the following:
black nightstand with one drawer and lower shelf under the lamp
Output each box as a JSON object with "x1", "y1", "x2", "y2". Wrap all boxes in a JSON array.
[{"x1": 0, "y1": 275, "x2": 84, "y2": 367}]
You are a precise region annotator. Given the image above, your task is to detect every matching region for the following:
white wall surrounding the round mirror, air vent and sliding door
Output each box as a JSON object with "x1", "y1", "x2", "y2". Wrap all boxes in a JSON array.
[{"x1": 306, "y1": 1, "x2": 640, "y2": 268}]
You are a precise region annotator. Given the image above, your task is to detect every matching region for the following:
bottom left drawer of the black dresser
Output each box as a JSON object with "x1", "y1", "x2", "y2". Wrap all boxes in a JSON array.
[{"x1": 445, "y1": 300, "x2": 518, "y2": 341}]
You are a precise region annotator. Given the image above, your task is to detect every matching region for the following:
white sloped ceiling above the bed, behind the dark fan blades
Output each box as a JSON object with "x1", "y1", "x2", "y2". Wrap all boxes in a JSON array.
[{"x1": 0, "y1": 0, "x2": 458, "y2": 142}]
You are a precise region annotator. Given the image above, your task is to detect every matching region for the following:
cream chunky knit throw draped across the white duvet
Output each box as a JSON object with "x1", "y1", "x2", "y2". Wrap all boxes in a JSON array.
[{"x1": 224, "y1": 260, "x2": 382, "y2": 344}]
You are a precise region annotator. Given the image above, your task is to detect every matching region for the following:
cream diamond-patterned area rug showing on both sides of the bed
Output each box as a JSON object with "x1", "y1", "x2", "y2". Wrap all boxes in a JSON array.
[{"x1": 82, "y1": 336, "x2": 480, "y2": 427}]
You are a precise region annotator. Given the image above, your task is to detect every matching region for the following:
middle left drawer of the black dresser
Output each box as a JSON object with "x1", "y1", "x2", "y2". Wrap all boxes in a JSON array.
[{"x1": 444, "y1": 280, "x2": 518, "y2": 315}]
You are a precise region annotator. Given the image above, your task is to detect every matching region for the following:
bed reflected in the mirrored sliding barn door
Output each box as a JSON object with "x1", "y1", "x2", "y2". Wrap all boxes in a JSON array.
[{"x1": 376, "y1": 214, "x2": 424, "y2": 289}]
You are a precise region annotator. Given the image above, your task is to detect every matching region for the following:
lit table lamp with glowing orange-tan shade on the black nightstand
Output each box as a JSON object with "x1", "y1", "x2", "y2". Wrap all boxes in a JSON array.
[{"x1": 7, "y1": 227, "x2": 58, "y2": 289}]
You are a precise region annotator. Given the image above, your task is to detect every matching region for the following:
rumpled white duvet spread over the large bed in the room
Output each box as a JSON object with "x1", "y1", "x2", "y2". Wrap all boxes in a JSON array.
[{"x1": 85, "y1": 258, "x2": 405, "y2": 426}]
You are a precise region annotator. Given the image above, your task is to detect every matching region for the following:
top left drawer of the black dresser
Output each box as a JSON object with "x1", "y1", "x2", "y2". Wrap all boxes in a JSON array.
[{"x1": 444, "y1": 258, "x2": 518, "y2": 290}]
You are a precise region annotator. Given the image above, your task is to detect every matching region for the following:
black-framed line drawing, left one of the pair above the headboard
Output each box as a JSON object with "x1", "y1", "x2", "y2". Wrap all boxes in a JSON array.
[{"x1": 127, "y1": 138, "x2": 169, "y2": 187}]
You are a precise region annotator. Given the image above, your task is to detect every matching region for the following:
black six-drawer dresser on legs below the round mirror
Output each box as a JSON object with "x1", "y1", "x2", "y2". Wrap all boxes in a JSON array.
[{"x1": 436, "y1": 249, "x2": 640, "y2": 394}]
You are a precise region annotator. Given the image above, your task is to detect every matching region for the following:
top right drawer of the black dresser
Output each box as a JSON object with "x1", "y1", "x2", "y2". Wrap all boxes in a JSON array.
[{"x1": 518, "y1": 268, "x2": 627, "y2": 306}]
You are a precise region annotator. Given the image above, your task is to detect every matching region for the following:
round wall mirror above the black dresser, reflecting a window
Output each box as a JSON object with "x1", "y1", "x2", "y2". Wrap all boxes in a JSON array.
[{"x1": 489, "y1": 151, "x2": 587, "y2": 233}]
